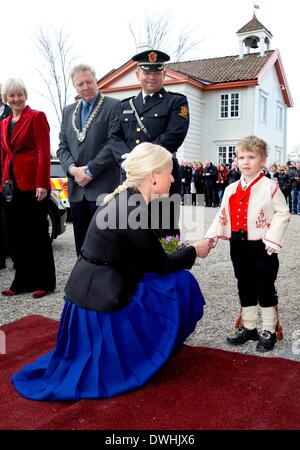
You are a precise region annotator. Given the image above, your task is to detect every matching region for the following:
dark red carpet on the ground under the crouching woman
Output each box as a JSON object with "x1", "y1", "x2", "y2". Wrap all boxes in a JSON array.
[{"x1": 0, "y1": 316, "x2": 300, "y2": 430}]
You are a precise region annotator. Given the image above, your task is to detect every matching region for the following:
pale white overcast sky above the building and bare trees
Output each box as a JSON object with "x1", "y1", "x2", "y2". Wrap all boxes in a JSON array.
[{"x1": 0, "y1": 0, "x2": 300, "y2": 158}]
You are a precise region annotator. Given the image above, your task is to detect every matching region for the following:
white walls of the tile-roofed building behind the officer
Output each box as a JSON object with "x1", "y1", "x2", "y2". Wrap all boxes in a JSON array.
[{"x1": 103, "y1": 62, "x2": 287, "y2": 163}]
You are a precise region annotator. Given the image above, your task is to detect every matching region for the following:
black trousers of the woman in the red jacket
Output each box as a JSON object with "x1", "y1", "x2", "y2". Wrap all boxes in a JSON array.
[{"x1": 5, "y1": 188, "x2": 56, "y2": 293}]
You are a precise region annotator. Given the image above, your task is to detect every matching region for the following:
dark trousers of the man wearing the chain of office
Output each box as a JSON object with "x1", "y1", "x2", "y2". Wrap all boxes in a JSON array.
[{"x1": 70, "y1": 197, "x2": 97, "y2": 256}]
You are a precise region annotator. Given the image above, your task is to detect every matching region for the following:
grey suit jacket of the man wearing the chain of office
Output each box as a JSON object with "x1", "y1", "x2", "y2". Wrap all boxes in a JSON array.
[{"x1": 57, "y1": 97, "x2": 120, "y2": 202}]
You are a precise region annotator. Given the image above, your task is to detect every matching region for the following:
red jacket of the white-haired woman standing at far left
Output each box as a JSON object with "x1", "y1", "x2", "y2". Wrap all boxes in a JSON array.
[{"x1": 0, "y1": 106, "x2": 50, "y2": 191}]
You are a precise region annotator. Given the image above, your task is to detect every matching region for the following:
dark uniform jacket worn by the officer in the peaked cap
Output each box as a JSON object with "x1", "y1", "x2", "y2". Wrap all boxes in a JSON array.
[{"x1": 109, "y1": 88, "x2": 189, "y2": 163}]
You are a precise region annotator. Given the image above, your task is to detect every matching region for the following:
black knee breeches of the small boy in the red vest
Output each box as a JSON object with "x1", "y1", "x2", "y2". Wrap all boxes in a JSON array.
[{"x1": 230, "y1": 238, "x2": 279, "y2": 307}]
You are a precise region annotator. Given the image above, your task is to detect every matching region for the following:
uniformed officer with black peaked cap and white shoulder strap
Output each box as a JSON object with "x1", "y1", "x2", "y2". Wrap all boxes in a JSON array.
[{"x1": 110, "y1": 50, "x2": 189, "y2": 236}]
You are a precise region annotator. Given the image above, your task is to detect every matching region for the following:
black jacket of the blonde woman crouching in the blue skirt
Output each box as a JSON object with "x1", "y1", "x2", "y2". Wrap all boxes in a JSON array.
[{"x1": 65, "y1": 189, "x2": 196, "y2": 311}]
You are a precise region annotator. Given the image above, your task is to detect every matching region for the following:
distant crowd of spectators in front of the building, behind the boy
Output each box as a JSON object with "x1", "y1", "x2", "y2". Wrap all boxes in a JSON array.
[{"x1": 180, "y1": 158, "x2": 300, "y2": 214}]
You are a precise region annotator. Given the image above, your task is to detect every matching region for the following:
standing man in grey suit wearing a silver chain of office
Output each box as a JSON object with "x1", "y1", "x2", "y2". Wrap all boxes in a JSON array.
[{"x1": 57, "y1": 64, "x2": 120, "y2": 255}]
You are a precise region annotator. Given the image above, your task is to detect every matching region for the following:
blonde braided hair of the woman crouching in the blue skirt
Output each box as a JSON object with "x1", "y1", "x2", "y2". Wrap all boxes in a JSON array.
[{"x1": 103, "y1": 142, "x2": 172, "y2": 204}]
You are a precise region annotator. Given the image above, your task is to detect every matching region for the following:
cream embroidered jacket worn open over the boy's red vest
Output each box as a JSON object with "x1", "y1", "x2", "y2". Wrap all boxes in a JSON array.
[{"x1": 205, "y1": 177, "x2": 290, "y2": 249}]
